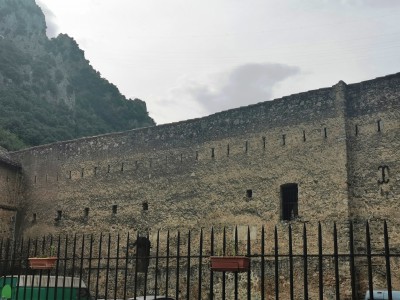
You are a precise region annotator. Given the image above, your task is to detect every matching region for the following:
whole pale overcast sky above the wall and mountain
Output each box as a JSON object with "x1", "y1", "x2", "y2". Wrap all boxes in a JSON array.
[{"x1": 36, "y1": 0, "x2": 400, "y2": 124}]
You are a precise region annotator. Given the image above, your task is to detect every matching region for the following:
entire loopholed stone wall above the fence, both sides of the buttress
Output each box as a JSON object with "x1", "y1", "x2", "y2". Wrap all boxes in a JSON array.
[{"x1": 0, "y1": 73, "x2": 400, "y2": 241}]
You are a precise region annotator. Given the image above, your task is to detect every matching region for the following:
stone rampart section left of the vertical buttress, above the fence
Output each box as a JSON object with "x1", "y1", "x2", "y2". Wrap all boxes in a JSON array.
[{"x1": 9, "y1": 81, "x2": 348, "y2": 238}]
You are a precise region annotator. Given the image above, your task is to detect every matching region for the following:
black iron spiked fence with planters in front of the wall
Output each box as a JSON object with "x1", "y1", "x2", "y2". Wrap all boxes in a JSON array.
[{"x1": 0, "y1": 222, "x2": 400, "y2": 300}]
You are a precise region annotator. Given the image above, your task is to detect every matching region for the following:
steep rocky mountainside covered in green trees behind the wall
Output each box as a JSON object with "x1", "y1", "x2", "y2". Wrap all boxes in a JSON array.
[{"x1": 0, "y1": 0, "x2": 154, "y2": 150}]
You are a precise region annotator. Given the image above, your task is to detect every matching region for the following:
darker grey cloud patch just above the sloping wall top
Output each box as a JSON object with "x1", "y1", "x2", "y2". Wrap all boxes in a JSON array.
[{"x1": 187, "y1": 63, "x2": 300, "y2": 113}]
